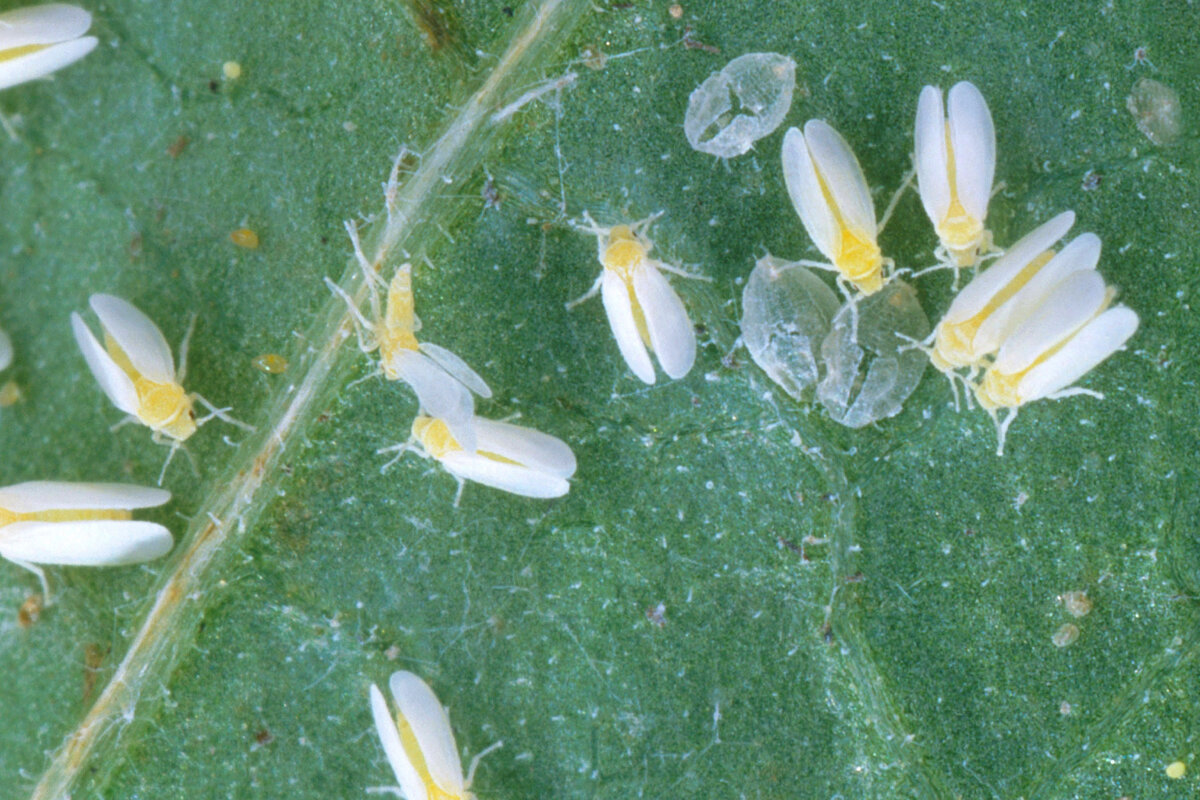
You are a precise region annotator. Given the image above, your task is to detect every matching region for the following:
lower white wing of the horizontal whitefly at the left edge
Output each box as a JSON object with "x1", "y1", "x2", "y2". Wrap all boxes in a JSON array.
[{"x1": 0, "y1": 519, "x2": 173, "y2": 566}]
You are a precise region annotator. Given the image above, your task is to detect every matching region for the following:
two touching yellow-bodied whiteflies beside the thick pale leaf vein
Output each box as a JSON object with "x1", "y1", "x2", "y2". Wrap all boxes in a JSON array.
[{"x1": 325, "y1": 223, "x2": 575, "y2": 503}]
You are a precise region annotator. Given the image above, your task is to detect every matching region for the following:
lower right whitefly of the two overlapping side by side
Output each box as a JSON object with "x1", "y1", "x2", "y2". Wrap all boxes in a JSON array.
[{"x1": 976, "y1": 270, "x2": 1138, "y2": 453}]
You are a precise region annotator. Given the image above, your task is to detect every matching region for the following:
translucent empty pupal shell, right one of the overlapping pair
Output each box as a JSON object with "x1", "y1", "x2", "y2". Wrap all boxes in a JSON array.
[{"x1": 817, "y1": 281, "x2": 930, "y2": 428}]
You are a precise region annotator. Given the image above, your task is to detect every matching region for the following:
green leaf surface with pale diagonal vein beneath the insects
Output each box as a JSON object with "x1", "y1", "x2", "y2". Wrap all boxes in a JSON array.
[{"x1": 0, "y1": 0, "x2": 1200, "y2": 799}]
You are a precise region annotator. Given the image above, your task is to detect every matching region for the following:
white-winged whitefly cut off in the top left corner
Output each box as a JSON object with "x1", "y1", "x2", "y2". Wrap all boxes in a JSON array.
[{"x1": 0, "y1": 2, "x2": 97, "y2": 89}]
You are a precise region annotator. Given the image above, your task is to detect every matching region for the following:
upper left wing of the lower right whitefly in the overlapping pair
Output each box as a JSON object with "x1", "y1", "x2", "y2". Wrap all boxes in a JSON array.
[{"x1": 991, "y1": 271, "x2": 1108, "y2": 375}]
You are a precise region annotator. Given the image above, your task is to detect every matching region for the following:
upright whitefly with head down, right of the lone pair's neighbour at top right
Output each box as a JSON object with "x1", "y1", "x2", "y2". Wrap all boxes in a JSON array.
[{"x1": 914, "y1": 82, "x2": 996, "y2": 266}]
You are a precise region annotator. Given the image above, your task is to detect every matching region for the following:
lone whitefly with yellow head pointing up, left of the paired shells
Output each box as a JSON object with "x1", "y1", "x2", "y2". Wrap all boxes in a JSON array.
[{"x1": 566, "y1": 212, "x2": 700, "y2": 384}]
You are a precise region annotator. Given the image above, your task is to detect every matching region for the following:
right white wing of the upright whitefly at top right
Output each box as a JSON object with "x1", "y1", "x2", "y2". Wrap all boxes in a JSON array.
[{"x1": 948, "y1": 80, "x2": 996, "y2": 222}]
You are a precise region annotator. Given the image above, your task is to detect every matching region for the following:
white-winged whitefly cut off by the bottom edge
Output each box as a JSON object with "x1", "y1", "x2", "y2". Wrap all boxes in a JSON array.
[{"x1": 371, "y1": 672, "x2": 500, "y2": 800}]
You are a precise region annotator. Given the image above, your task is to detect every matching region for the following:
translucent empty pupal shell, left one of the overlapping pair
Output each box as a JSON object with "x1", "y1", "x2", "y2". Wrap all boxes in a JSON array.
[{"x1": 742, "y1": 254, "x2": 839, "y2": 399}]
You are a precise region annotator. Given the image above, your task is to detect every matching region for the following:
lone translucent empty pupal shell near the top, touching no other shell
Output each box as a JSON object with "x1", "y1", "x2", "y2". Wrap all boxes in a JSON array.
[{"x1": 683, "y1": 53, "x2": 796, "y2": 158}]
